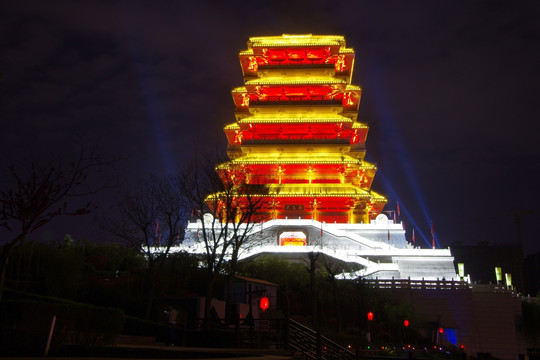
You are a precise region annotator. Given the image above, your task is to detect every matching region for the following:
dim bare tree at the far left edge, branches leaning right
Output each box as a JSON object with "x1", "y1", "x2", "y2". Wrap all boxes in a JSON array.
[{"x1": 0, "y1": 144, "x2": 118, "y2": 299}]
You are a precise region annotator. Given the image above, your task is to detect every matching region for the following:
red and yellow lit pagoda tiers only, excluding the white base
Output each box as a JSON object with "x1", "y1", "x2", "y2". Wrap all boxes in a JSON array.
[{"x1": 218, "y1": 35, "x2": 386, "y2": 224}]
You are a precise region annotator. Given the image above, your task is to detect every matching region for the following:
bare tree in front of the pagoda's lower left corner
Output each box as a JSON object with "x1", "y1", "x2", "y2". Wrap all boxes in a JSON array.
[{"x1": 178, "y1": 157, "x2": 266, "y2": 321}]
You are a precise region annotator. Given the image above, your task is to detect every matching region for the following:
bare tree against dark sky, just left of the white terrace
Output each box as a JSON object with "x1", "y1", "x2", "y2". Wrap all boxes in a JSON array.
[{"x1": 103, "y1": 177, "x2": 188, "y2": 319}]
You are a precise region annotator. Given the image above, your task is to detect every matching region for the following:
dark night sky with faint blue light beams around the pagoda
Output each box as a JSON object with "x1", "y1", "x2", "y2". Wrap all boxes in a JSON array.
[{"x1": 0, "y1": 0, "x2": 540, "y2": 253}]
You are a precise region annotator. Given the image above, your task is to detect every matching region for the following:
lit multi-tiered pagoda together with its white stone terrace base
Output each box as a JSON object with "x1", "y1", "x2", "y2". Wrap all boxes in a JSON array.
[{"x1": 184, "y1": 35, "x2": 457, "y2": 279}]
